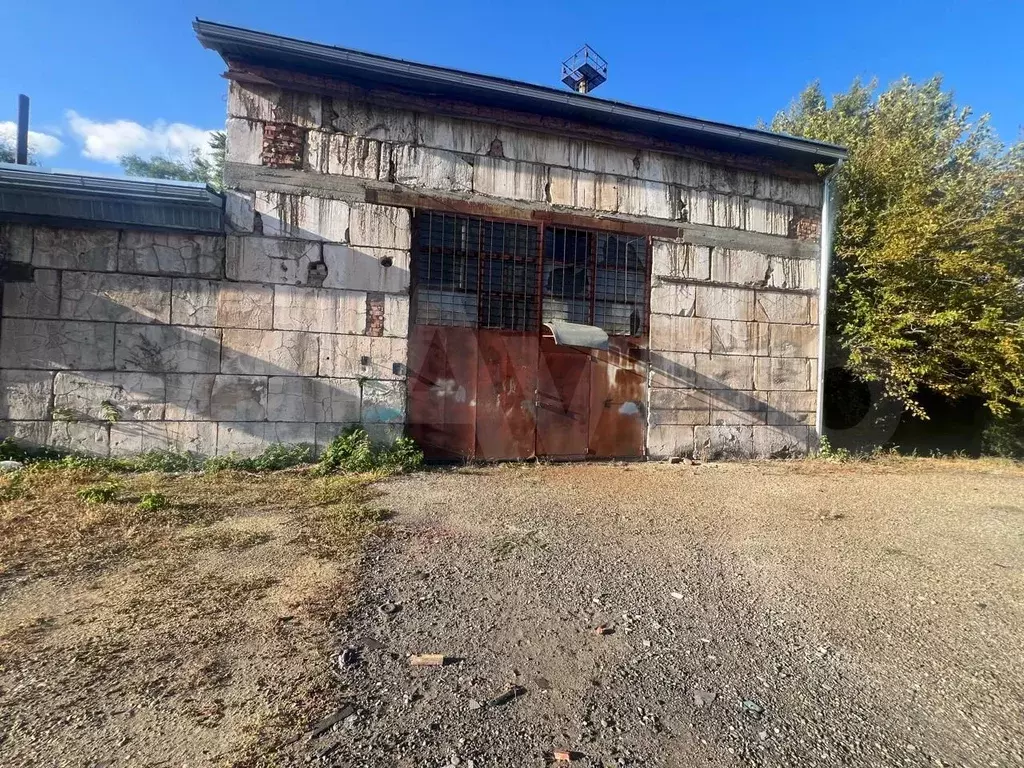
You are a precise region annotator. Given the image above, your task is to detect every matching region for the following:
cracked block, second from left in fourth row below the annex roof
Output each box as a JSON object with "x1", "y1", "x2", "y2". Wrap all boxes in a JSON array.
[{"x1": 53, "y1": 371, "x2": 166, "y2": 422}]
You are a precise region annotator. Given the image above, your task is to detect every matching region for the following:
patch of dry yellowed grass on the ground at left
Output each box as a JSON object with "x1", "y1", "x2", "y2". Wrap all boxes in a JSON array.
[{"x1": 0, "y1": 469, "x2": 389, "y2": 766}]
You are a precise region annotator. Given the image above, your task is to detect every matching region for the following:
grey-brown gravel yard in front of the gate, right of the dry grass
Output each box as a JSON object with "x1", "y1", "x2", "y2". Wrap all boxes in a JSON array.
[{"x1": 303, "y1": 461, "x2": 1024, "y2": 768}]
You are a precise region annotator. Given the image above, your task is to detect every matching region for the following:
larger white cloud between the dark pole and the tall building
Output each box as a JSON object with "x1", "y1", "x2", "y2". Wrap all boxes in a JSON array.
[{"x1": 68, "y1": 110, "x2": 213, "y2": 163}]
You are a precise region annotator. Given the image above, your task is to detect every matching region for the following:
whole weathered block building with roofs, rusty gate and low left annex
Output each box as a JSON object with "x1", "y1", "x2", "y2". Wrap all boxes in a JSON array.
[{"x1": 0, "y1": 22, "x2": 845, "y2": 459}]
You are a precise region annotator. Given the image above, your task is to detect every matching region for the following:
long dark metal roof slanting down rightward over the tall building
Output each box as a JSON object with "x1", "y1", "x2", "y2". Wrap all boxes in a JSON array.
[{"x1": 193, "y1": 19, "x2": 847, "y2": 167}]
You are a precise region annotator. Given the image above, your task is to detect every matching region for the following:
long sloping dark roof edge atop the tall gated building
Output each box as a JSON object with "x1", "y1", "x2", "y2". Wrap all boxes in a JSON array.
[{"x1": 193, "y1": 18, "x2": 847, "y2": 163}]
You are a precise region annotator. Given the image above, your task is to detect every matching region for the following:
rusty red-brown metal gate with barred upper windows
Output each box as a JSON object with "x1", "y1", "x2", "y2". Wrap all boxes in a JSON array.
[{"x1": 409, "y1": 211, "x2": 649, "y2": 460}]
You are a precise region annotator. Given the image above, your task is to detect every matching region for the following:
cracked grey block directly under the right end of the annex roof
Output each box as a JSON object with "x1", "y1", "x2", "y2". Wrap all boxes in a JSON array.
[{"x1": 118, "y1": 231, "x2": 224, "y2": 278}]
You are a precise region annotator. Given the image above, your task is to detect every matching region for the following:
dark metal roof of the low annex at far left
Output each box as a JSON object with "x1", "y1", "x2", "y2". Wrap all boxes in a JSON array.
[{"x1": 0, "y1": 163, "x2": 224, "y2": 232}]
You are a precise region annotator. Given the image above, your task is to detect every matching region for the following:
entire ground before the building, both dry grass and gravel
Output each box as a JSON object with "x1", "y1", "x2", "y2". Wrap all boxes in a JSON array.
[{"x1": 0, "y1": 461, "x2": 1024, "y2": 768}]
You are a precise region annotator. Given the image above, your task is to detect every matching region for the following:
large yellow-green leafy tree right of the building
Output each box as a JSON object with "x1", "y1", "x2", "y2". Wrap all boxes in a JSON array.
[{"x1": 771, "y1": 78, "x2": 1024, "y2": 416}]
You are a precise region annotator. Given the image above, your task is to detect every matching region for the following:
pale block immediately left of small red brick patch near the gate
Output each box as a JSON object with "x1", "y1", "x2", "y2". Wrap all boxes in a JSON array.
[{"x1": 273, "y1": 286, "x2": 367, "y2": 334}]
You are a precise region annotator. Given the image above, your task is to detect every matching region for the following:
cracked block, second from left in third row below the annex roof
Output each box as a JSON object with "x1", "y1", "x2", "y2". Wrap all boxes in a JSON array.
[{"x1": 114, "y1": 325, "x2": 220, "y2": 374}]
